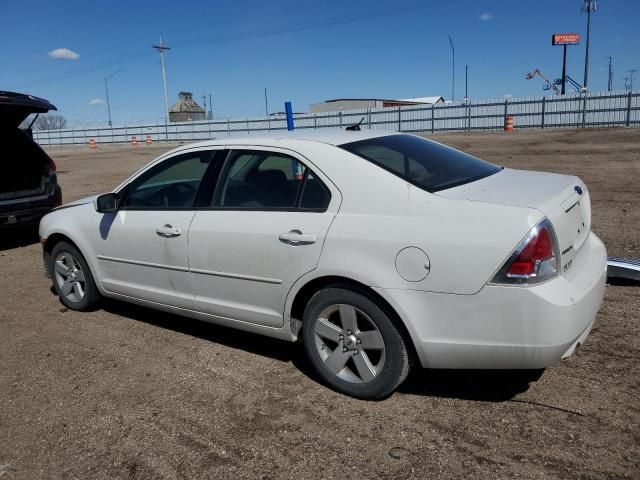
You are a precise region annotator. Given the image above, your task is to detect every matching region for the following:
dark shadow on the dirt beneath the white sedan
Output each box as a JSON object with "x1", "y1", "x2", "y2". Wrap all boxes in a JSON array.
[{"x1": 101, "y1": 299, "x2": 543, "y2": 402}]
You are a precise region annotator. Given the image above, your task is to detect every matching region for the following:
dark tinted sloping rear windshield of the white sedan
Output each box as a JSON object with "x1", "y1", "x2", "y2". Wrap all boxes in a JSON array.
[{"x1": 340, "y1": 135, "x2": 501, "y2": 192}]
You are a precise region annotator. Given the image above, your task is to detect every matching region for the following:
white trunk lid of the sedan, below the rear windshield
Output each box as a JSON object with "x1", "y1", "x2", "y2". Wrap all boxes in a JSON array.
[{"x1": 437, "y1": 168, "x2": 591, "y2": 272}]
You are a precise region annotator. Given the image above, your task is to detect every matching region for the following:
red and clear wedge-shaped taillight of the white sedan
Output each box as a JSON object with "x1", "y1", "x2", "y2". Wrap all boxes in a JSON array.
[{"x1": 491, "y1": 218, "x2": 559, "y2": 285}]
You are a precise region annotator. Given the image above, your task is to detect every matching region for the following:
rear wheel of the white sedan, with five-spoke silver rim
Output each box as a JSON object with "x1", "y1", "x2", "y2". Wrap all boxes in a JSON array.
[{"x1": 302, "y1": 287, "x2": 410, "y2": 400}]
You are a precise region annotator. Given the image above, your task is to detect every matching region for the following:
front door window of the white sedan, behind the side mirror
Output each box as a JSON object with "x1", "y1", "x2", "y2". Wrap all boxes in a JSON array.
[{"x1": 121, "y1": 152, "x2": 212, "y2": 210}]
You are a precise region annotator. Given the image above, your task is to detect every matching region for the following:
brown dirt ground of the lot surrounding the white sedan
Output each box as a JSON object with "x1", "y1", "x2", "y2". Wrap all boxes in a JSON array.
[{"x1": 0, "y1": 129, "x2": 640, "y2": 480}]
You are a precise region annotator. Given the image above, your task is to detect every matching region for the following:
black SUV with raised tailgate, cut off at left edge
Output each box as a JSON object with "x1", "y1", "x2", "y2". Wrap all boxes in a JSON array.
[{"x1": 0, "y1": 91, "x2": 62, "y2": 228}]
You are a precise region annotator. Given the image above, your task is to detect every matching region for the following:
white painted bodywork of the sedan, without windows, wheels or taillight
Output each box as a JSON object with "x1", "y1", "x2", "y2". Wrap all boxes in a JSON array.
[{"x1": 40, "y1": 131, "x2": 606, "y2": 368}]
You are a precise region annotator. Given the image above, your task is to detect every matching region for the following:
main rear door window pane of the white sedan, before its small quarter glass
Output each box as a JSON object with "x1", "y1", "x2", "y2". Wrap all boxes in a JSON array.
[{"x1": 214, "y1": 151, "x2": 307, "y2": 209}]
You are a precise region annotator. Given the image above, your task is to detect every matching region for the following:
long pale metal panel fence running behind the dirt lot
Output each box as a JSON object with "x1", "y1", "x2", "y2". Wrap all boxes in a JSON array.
[{"x1": 34, "y1": 91, "x2": 640, "y2": 145}]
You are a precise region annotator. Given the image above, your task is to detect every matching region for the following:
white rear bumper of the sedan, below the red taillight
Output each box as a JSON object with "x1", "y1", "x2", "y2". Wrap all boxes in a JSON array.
[{"x1": 378, "y1": 233, "x2": 607, "y2": 369}]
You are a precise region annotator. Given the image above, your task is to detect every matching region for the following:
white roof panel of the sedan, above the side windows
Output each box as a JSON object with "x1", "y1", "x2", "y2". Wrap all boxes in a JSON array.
[{"x1": 170, "y1": 129, "x2": 398, "y2": 150}]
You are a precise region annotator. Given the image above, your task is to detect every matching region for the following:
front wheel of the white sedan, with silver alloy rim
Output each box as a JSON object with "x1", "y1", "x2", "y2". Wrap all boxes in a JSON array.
[{"x1": 49, "y1": 242, "x2": 100, "y2": 311}]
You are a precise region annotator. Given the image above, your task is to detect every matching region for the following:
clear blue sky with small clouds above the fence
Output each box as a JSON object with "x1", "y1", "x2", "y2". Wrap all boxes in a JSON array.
[{"x1": 0, "y1": 0, "x2": 640, "y2": 127}]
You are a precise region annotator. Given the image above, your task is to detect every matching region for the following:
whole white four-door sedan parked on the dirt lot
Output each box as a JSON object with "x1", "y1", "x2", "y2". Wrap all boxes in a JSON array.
[{"x1": 40, "y1": 131, "x2": 606, "y2": 398}]
